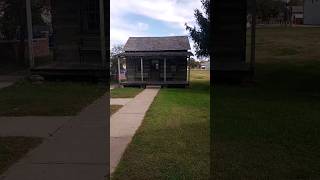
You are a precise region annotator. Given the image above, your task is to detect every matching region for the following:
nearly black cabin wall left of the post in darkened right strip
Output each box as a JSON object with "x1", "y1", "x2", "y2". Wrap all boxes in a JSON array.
[{"x1": 212, "y1": 0, "x2": 247, "y2": 63}]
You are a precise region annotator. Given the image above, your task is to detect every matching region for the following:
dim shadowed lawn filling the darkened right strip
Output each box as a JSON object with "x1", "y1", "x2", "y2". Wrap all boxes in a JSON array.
[{"x1": 212, "y1": 28, "x2": 320, "y2": 180}]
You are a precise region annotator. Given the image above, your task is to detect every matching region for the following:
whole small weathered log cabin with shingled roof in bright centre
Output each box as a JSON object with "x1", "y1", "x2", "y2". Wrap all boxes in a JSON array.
[{"x1": 119, "y1": 36, "x2": 193, "y2": 87}]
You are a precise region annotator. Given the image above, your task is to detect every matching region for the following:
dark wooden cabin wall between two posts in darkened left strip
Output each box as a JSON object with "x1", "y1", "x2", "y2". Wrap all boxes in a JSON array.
[{"x1": 51, "y1": 0, "x2": 109, "y2": 64}]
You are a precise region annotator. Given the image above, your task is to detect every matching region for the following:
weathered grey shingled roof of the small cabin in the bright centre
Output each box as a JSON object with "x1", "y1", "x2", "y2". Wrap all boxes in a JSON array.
[{"x1": 124, "y1": 36, "x2": 191, "y2": 52}]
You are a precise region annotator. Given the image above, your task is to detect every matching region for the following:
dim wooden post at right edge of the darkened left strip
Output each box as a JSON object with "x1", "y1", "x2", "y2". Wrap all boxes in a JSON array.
[{"x1": 99, "y1": 0, "x2": 107, "y2": 67}]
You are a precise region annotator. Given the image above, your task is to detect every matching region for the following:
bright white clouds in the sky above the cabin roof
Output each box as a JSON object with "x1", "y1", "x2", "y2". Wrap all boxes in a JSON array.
[{"x1": 110, "y1": 0, "x2": 201, "y2": 55}]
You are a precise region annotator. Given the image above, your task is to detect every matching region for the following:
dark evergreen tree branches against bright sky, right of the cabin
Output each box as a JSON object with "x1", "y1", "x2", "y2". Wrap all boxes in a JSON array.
[{"x1": 185, "y1": 0, "x2": 210, "y2": 57}]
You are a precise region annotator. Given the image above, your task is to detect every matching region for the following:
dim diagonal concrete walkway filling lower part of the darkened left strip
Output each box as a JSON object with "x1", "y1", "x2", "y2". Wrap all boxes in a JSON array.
[{"x1": 0, "y1": 96, "x2": 109, "y2": 180}]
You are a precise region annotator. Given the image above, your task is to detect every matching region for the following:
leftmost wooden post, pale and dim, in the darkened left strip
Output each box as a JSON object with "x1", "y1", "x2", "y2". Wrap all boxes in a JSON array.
[{"x1": 26, "y1": 0, "x2": 34, "y2": 68}]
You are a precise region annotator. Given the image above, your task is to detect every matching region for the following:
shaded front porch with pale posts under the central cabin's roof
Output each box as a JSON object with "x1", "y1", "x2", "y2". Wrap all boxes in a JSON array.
[{"x1": 120, "y1": 57, "x2": 190, "y2": 87}]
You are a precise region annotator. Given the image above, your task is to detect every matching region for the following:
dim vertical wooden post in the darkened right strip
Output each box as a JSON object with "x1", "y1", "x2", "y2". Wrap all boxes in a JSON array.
[{"x1": 250, "y1": 0, "x2": 256, "y2": 72}]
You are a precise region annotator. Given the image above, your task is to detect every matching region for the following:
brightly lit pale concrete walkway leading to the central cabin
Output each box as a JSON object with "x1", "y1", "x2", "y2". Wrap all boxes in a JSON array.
[{"x1": 110, "y1": 89, "x2": 159, "y2": 174}]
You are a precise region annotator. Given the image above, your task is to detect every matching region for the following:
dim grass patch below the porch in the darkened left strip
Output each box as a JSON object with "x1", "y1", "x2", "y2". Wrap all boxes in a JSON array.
[{"x1": 0, "y1": 81, "x2": 106, "y2": 116}]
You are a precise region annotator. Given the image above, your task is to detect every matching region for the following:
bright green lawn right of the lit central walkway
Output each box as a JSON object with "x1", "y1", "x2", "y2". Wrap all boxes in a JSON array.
[{"x1": 113, "y1": 71, "x2": 210, "y2": 180}]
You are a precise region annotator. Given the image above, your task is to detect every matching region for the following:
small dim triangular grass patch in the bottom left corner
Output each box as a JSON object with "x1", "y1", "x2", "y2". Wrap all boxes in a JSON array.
[{"x1": 0, "y1": 137, "x2": 42, "y2": 174}]
